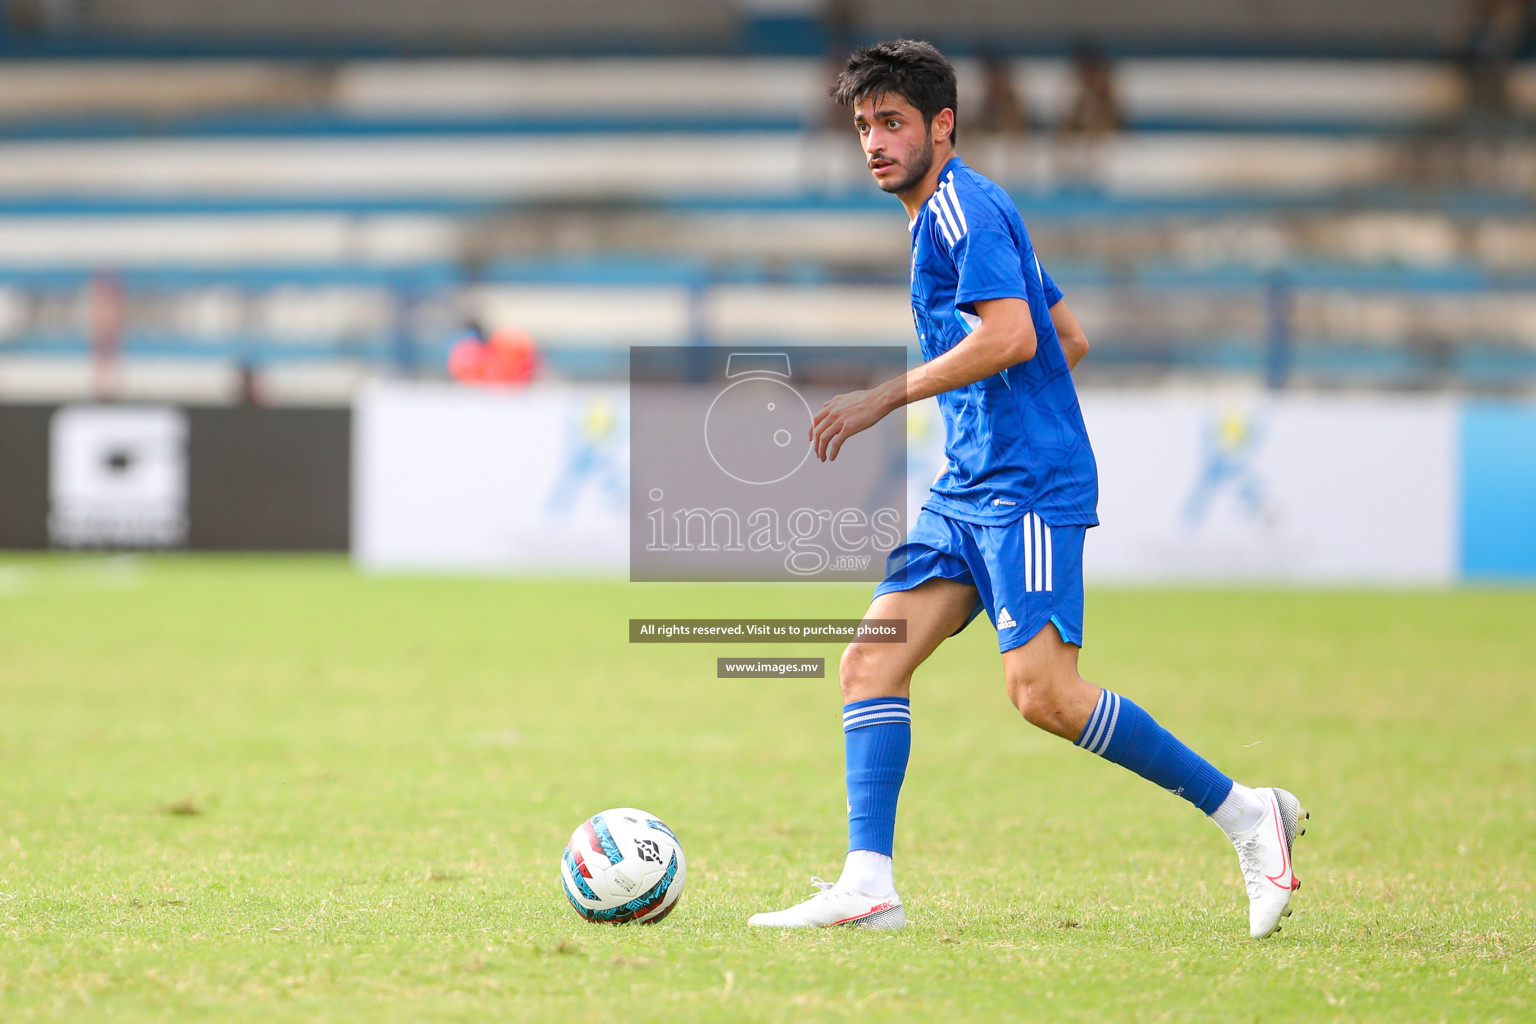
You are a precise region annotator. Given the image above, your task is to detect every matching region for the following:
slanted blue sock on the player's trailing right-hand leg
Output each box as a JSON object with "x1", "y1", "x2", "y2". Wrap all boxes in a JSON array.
[{"x1": 1077, "y1": 689, "x2": 1232, "y2": 814}]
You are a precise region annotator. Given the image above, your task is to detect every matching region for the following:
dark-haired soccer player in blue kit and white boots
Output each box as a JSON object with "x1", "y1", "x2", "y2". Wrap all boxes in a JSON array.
[{"x1": 750, "y1": 40, "x2": 1307, "y2": 938}]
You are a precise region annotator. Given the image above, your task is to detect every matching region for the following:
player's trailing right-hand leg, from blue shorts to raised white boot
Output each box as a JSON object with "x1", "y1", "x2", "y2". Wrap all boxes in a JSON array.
[{"x1": 992, "y1": 517, "x2": 1307, "y2": 938}]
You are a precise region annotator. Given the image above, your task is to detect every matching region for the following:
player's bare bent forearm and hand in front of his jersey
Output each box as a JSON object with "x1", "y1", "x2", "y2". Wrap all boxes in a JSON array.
[{"x1": 811, "y1": 298, "x2": 1035, "y2": 462}]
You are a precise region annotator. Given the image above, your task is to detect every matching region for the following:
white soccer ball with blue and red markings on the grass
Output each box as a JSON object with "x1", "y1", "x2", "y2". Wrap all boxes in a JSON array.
[{"x1": 561, "y1": 808, "x2": 687, "y2": 924}]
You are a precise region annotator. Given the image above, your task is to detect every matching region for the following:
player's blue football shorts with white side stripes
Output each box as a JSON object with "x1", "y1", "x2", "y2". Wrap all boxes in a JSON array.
[{"x1": 874, "y1": 508, "x2": 1087, "y2": 651}]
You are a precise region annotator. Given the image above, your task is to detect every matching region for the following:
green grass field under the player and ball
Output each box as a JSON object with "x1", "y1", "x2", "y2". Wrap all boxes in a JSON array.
[{"x1": 0, "y1": 557, "x2": 1536, "y2": 1022}]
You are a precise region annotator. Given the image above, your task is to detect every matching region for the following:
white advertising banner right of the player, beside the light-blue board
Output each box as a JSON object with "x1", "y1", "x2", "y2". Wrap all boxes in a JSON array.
[{"x1": 1081, "y1": 391, "x2": 1459, "y2": 583}]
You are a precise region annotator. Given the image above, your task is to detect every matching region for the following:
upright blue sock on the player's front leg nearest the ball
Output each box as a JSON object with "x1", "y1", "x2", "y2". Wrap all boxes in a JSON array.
[{"x1": 843, "y1": 697, "x2": 912, "y2": 857}]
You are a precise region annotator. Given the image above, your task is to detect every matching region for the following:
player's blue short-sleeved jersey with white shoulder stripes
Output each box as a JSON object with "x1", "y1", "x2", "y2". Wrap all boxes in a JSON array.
[{"x1": 912, "y1": 157, "x2": 1098, "y2": 527}]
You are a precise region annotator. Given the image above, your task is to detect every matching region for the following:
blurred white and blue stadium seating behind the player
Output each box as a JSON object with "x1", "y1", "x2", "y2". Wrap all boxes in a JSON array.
[{"x1": 0, "y1": 11, "x2": 1536, "y2": 399}]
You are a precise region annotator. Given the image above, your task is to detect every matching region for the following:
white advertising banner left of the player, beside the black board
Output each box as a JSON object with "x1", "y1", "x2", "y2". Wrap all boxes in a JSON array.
[{"x1": 352, "y1": 384, "x2": 630, "y2": 573}]
